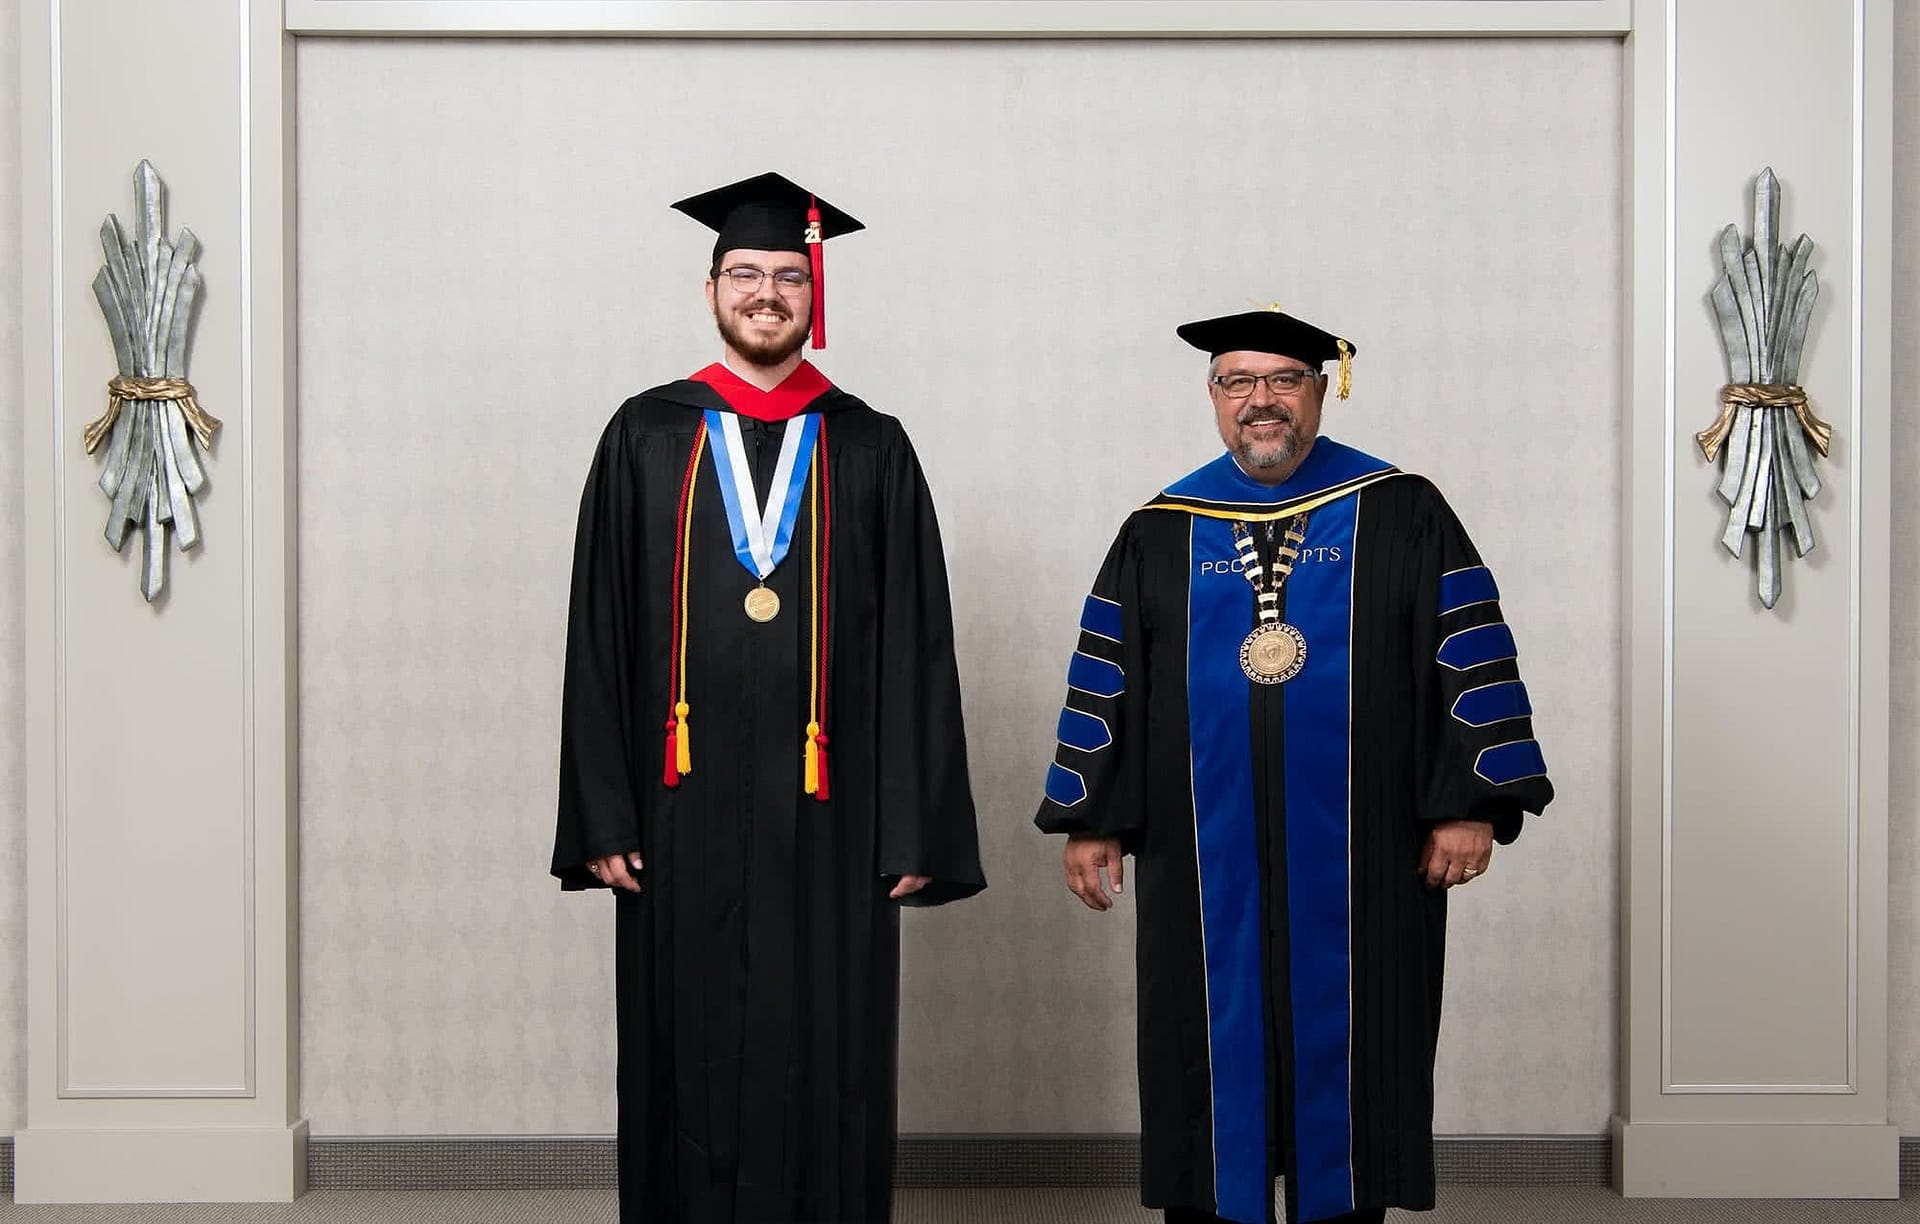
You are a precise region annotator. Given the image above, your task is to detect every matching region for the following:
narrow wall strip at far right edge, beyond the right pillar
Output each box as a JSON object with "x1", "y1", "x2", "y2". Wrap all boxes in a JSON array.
[{"x1": 1887, "y1": 4, "x2": 1920, "y2": 1136}]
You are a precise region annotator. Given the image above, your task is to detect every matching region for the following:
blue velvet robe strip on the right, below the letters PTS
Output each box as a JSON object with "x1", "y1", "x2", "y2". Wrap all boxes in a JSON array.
[{"x1": 1283, "y1": 497, "x2": 1359, "y2": 1220}]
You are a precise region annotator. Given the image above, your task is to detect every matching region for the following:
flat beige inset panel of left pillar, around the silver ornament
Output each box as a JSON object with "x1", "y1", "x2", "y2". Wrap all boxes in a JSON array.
[{"x1": 47, "y1": 0, "x2": 250, "y2": 1090}]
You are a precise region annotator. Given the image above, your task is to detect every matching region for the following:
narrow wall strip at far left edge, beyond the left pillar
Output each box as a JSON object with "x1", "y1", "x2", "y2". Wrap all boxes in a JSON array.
[{"x1": 0, "y1": 4, "x2": 27, "y2": 1134}]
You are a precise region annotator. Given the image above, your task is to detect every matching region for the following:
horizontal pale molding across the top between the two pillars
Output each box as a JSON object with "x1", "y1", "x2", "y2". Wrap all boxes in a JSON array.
[{"x1": 284, "y1": 0, "x2": 1632, "y2": 38}]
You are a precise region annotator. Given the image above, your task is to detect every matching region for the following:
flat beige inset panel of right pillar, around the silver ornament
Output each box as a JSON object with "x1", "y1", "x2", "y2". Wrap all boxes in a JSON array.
[{"x1": 1668, "y1": 4, "x2": 1853, "y2": 1084}]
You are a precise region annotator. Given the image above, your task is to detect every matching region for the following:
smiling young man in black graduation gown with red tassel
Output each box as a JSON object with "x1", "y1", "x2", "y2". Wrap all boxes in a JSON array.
[{"x1": 553, "y1": 175, "x2": 985, "y2": 1224}]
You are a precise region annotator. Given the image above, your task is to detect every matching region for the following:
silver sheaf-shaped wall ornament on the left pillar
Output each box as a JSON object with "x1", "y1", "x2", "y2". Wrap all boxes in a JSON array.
[{"x1": 81, "y1": 161, "x2": 221, "y2": 602}]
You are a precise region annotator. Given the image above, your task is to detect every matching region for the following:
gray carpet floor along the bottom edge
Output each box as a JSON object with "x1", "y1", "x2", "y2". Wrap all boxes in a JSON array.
[{"x1": 0, "y1": 1186, "x2": 1920, "y2": 1224}]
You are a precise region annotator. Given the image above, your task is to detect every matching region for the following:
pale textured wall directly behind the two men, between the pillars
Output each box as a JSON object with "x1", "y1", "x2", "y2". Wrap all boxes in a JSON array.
[{"x1": 298, "y1": 40, "x2": 1622, "y2": 1134}]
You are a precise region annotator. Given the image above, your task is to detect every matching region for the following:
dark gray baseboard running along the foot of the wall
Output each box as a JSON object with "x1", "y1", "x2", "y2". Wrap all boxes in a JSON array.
[{"x1": 0, "y1": 1136, "x2": 1920, "y2": 1199}]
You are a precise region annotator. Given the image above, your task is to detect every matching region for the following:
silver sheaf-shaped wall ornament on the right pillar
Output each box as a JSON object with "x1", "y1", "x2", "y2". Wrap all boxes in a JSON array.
[{"x1": 1693, "y1": 169, "x2": 1834, "y2": 608}]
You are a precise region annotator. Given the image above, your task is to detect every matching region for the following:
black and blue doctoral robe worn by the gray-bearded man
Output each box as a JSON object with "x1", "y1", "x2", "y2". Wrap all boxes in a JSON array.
[{"x1": 1037, "y1": 437, "x2": 1553, "y2": 1224}]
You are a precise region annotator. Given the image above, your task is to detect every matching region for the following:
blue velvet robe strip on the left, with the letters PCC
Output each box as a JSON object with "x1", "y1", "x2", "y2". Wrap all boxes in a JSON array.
[{"x1": 1187, "y1": 516, "x2": 1273, "y2": 1224}]
